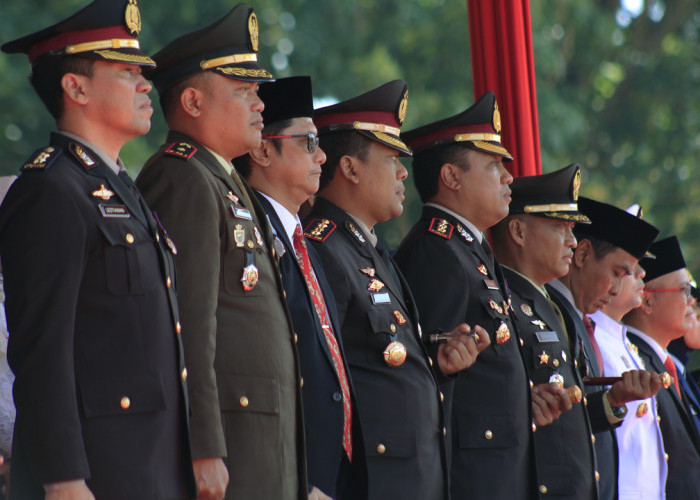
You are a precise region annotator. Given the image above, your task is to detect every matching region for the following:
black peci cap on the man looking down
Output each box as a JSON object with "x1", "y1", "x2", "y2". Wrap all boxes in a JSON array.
[{"x1": 576, "y1": 196, "x2": 659, "y2": 259}]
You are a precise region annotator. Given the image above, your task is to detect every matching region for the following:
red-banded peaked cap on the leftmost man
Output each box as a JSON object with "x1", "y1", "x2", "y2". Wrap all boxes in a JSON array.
[{"x1": 2, "y1": 0, "x2": 155, "y2": 66}]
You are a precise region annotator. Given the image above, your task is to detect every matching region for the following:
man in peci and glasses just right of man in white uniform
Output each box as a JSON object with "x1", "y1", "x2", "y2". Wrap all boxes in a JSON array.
[{"x1": 625, "y1": 236, "x2": 700, "y2": 499}]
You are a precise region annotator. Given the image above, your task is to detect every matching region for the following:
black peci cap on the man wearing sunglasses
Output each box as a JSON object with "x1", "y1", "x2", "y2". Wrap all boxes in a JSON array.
[{"x1": 258, "y1": 76, "x2": 314, "y2": 126}]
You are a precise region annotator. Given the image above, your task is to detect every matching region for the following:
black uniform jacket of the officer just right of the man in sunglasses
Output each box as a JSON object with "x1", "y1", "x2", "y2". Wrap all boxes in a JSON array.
[{"x1": 305, "y1": 198, "x2": 447, "y2": 500}]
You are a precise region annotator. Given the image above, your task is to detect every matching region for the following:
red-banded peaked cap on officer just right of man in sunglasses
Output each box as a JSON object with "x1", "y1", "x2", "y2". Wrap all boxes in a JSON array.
[{"x1": 314, "y1": 80, "x2": 411, "y2": 156}]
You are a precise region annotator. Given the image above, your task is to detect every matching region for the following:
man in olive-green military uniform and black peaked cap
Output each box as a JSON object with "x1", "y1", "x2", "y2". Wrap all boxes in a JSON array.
[{"x1": 137, "y1": 4, "x2": 307, "y2": 500}]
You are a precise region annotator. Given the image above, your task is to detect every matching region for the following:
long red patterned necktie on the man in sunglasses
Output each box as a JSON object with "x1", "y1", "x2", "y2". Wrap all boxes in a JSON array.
[{"x1": 294, "y1": 226, "x2": 352, "y2": 462}]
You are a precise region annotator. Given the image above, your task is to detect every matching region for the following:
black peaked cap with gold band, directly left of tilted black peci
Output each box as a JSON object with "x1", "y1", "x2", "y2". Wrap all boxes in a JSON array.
[{"x1": 509, "y1": 163, "x2": 591, "y2": 224}]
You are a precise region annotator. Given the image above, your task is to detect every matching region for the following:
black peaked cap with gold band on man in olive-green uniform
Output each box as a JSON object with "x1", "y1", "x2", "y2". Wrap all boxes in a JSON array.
[{"x1": 148, "y1": 3, "x2": 274, "y2": 94}]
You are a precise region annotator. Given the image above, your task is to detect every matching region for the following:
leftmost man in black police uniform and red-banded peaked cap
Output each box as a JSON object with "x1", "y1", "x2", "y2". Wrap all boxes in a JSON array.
[{"x1": 0, "y1": 0, "x2": 196, "y2": 500}]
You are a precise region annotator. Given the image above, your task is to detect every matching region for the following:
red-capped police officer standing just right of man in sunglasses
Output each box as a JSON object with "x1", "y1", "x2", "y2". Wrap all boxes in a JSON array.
[{"x1": 305, "y1": 80, "x2": 488, "y2": 500}]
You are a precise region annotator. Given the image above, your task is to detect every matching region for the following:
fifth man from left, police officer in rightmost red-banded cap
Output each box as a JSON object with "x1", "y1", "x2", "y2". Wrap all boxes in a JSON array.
[{"x1": 396, "y1": 92, "x2": 570, "y2": 499}]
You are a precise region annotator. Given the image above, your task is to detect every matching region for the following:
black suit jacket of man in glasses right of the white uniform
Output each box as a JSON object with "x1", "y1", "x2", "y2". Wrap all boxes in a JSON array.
[{"x1": 627, "y1": 329, "x2": 700, "y2": 500}]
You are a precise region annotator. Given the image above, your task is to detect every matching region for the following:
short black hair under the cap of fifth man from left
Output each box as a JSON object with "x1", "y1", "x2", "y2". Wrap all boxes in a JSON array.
[{"x1": 412, "y1": 143, "x2": 471, "y2": 203}]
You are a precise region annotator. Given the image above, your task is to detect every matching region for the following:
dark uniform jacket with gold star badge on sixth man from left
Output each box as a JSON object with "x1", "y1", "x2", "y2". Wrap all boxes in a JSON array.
[{"x1": 503, "y1": 269, "x2": 598, "y2": 500}]
